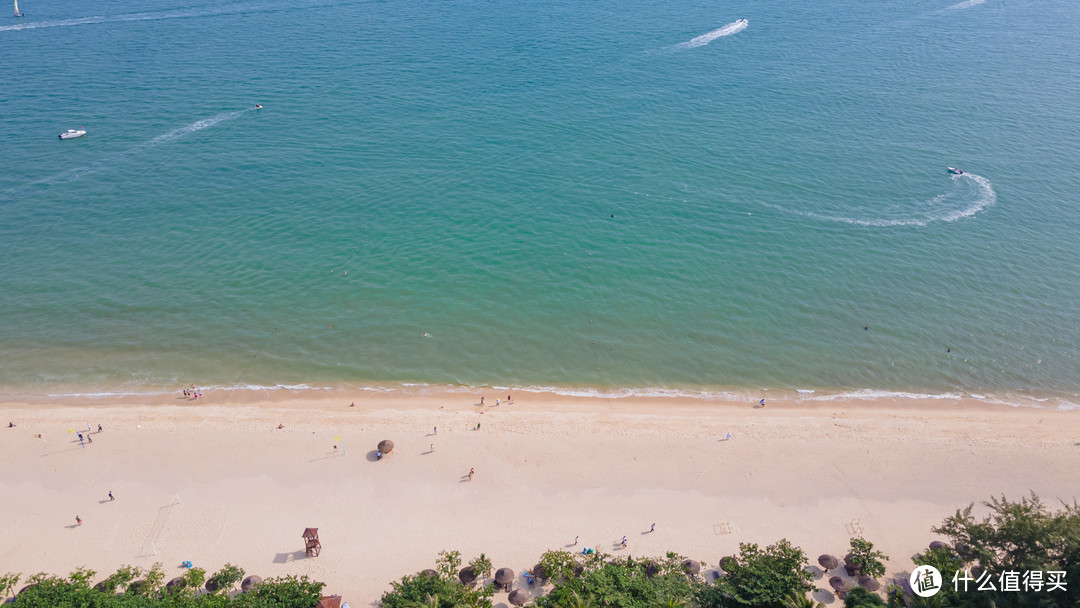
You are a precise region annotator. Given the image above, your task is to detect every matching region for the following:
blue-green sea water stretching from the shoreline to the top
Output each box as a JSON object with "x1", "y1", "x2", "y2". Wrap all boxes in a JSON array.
[{"x1": 0, "y1": 0, "x2": 1080, "y2": 405}]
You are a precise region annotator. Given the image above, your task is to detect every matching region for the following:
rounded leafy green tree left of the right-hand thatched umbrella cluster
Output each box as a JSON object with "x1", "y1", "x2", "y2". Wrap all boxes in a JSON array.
[{"x1": 697, "y1": 539, "x2": 813, "y2": 608}]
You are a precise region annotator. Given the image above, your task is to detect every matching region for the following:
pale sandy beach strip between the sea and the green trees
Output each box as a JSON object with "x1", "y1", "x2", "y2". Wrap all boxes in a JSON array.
[{"x1": 0, "y1": 390, "x2": 1080, "y2": 606}]
